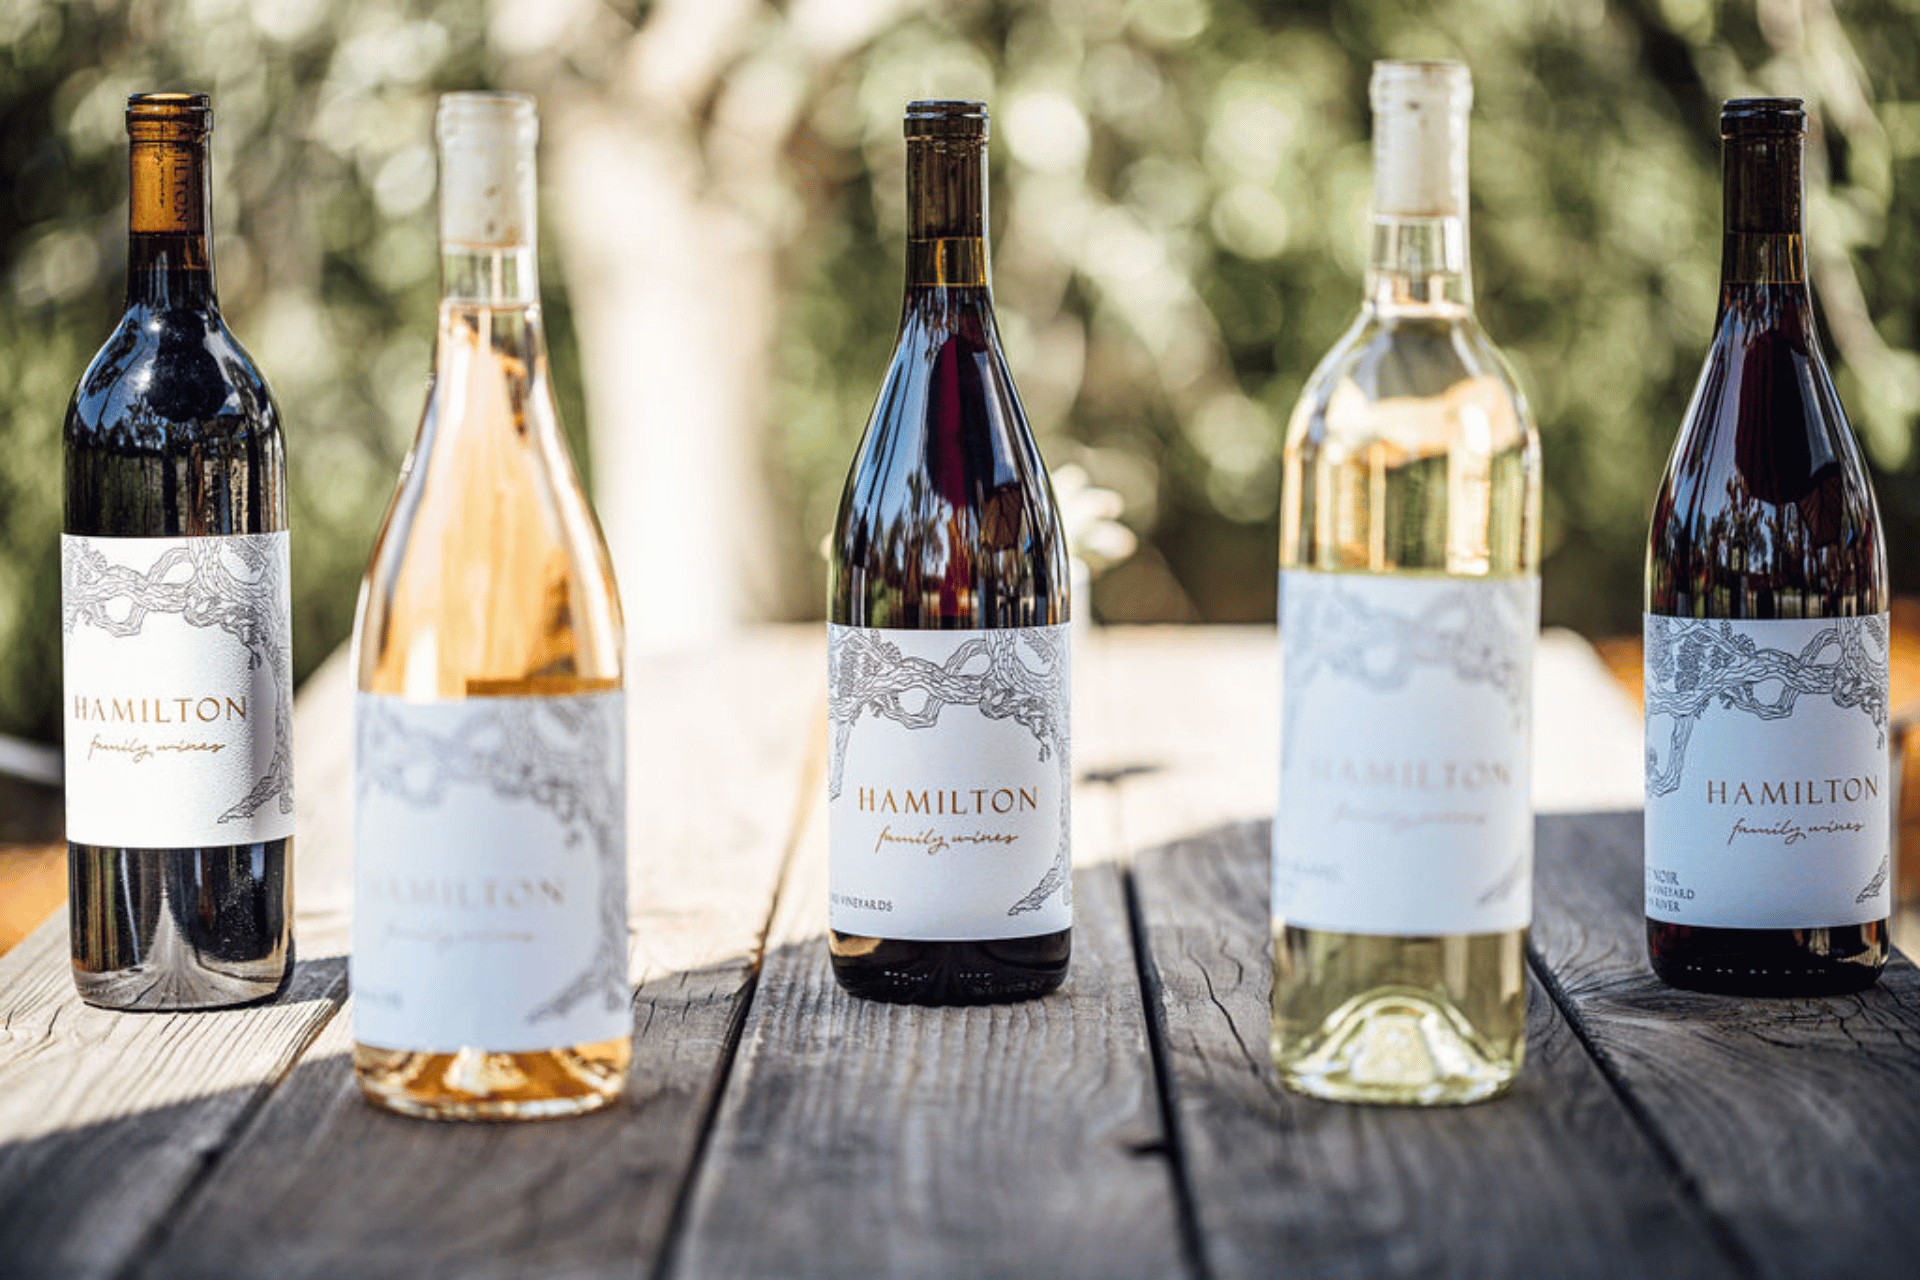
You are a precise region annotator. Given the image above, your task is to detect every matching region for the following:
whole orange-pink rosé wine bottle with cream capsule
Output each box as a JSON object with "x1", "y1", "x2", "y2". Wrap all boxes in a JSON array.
[{"x1": 351, "y1": 94, "x2": 634, "y2": 1119}]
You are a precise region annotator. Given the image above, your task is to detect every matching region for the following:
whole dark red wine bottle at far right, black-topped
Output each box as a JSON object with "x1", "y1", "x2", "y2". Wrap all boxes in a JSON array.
[{"x1": 1645, "y1": 98, "x2": 1893, "y2": 996}]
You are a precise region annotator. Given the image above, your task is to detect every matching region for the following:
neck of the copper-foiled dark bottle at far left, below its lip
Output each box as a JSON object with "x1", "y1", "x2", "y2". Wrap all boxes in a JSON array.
[{"x1": 127, "y1": 134, "x2": 215, "y2": 311}]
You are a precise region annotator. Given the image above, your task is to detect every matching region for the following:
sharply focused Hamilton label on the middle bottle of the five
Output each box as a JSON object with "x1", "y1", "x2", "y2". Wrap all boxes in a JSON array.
[{"x1": 828, "y1": 624, "x2": 1073, "y2": 940}]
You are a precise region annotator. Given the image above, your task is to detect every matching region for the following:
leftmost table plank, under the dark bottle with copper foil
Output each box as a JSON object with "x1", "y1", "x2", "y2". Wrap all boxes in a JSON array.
[{"x1": 0, "y1": 656, "x2": 362, "y2": 1278}]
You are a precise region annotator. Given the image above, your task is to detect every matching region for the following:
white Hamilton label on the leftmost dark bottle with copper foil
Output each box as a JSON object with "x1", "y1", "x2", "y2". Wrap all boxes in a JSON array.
[{"x1": 60, "y1": 532, "x2": 294, "y2": 848}]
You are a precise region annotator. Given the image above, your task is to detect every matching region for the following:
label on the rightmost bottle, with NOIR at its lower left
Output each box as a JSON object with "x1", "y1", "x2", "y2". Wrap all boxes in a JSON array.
[{"x1": 1645, "y1": 614, "x2": 1893, "y2": 929}]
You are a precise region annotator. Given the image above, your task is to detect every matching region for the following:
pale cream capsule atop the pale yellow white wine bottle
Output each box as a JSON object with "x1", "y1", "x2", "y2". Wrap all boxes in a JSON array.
[{"x1": 1367, "y1": 61, "x2": 1473, "y2": 217}]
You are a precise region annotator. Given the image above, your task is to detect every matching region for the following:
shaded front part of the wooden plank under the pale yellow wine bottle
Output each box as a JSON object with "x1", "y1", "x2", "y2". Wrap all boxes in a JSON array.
[{"x1": 1135, "y1": 821, "x2": 1740, "y2": 1280}]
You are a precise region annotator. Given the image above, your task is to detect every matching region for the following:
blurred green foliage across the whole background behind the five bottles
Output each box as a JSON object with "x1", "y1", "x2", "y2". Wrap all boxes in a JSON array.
[{"x1": 0, "y1": 0, "x2": 1920, "y2": 752}]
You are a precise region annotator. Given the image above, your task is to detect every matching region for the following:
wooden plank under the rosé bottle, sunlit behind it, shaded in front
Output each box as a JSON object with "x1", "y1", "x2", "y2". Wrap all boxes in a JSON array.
[{"x1": 140, "y1": 628, "x2": 826, "y2": 1276}]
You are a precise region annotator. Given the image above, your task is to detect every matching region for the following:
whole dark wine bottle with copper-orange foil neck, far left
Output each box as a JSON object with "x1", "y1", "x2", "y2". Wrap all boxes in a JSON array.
[{"x1": 60, "y1": 94, "x2": 294, "y2": 1009}]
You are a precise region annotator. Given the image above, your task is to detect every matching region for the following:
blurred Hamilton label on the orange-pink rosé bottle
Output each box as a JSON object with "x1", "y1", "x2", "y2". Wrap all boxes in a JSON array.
[{"x1": 351, "y1": 691, "x2": 634, "y2": 1054}]
